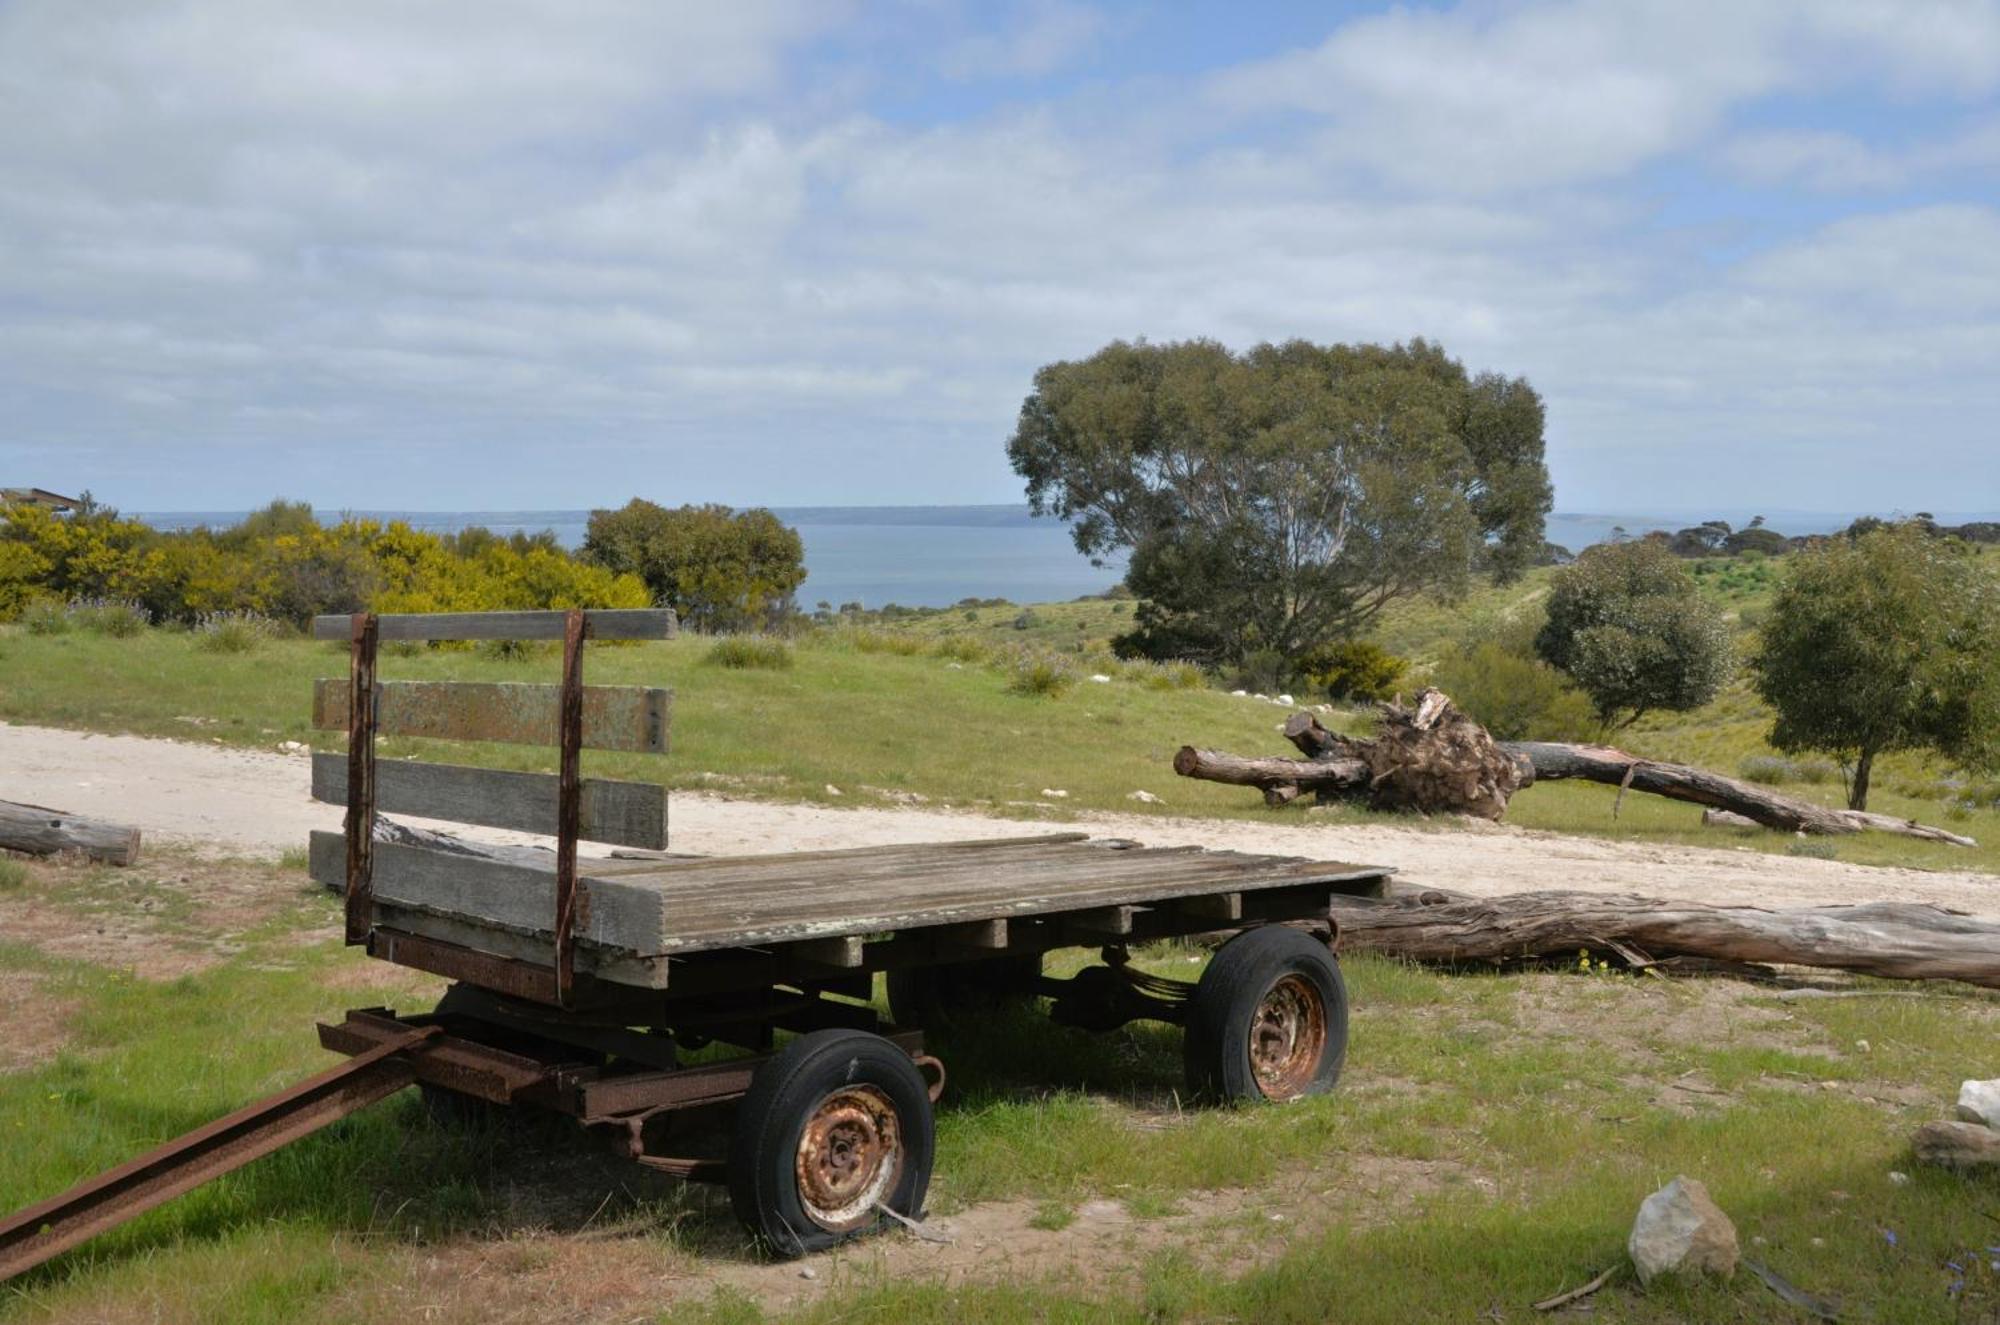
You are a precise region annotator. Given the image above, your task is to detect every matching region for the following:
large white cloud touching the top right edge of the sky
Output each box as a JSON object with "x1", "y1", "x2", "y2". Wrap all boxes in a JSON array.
[{"x1": 1210, "y1": 0, "x2": 2000, "y2": 194}]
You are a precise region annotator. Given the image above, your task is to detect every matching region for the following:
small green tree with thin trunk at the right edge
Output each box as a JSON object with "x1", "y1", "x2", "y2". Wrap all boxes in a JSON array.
[{"x1": 1754, "y1": 520, "x2": 2000, "y2": 811}]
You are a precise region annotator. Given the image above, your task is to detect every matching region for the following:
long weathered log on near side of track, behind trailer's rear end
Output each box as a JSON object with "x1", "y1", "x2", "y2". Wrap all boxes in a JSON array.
[{"x1": 1332, "y1": 889, "x2": 2000, "y2": 989}]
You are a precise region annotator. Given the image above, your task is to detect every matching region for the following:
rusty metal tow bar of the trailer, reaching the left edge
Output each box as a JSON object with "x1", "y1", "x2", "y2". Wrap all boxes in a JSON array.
[{"x1": 0, "y1": 1025, "x2": 438, "y2": 1279}]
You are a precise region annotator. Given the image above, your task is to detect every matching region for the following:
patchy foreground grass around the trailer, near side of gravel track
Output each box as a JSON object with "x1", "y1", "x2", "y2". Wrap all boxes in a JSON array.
[{"x1": 0, "y1": 853, "x2": 2000, "y2": 1323}]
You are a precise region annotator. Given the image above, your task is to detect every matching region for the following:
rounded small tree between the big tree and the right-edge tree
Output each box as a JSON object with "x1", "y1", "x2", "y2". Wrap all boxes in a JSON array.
[{"x1": 1534, "y1": 540, "x2": 1730, "y2": 731}]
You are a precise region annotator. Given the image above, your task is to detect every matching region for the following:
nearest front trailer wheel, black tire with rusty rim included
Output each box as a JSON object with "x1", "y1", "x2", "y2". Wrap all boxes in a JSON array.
[{"x1": 728, "y1": 1031, "x2": 936, "y2": 1257}]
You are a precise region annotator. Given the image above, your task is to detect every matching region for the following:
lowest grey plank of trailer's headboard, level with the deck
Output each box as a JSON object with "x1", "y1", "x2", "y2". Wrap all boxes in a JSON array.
[{"x1": 310, "y1": 833, "x2": 666, "y2": 957}]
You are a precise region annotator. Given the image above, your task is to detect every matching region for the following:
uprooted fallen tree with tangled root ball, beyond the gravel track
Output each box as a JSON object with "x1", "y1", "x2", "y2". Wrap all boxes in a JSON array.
[{"x1": 1208, "y1": 689, "x2": 1978, "y2": 847}]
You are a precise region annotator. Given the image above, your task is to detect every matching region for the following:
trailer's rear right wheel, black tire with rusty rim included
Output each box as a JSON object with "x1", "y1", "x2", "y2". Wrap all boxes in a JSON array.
[{"x1": 1184, "y1": 925, "x2": 1348, "y2": 1103}]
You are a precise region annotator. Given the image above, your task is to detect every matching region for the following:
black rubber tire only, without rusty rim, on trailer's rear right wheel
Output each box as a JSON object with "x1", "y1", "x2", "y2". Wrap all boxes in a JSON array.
[{"x1": 1182, "y1": 925, "x2": 1348, "y2": 1103}]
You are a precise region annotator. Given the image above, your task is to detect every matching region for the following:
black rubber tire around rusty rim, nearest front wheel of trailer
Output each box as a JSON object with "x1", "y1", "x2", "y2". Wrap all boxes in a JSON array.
[{"x1": 728, "y1": 1031, "x2": 936, "y2": 1257}]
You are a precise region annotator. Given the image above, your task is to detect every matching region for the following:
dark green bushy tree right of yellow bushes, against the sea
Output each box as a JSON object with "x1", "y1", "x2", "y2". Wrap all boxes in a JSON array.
[{"x1": 582, "y1": 496, "x2": 806, "y2": 630}]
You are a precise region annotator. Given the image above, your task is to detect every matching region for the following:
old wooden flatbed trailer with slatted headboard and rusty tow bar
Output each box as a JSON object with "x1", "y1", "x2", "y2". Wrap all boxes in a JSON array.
[{"x1": 0, "y1": 610, "x2": 1390, "y2": 1279}]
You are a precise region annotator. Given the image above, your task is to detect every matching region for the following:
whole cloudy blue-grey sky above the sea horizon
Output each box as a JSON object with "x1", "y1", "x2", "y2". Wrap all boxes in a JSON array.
[{"x1": 0, "y1": 0, "x2": 2000, "y2": 512}]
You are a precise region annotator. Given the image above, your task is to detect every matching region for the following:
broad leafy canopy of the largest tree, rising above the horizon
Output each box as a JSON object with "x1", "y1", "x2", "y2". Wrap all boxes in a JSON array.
[{"x1": 1008, "y1": 340, "x2": 1552, "y2": 663}]
